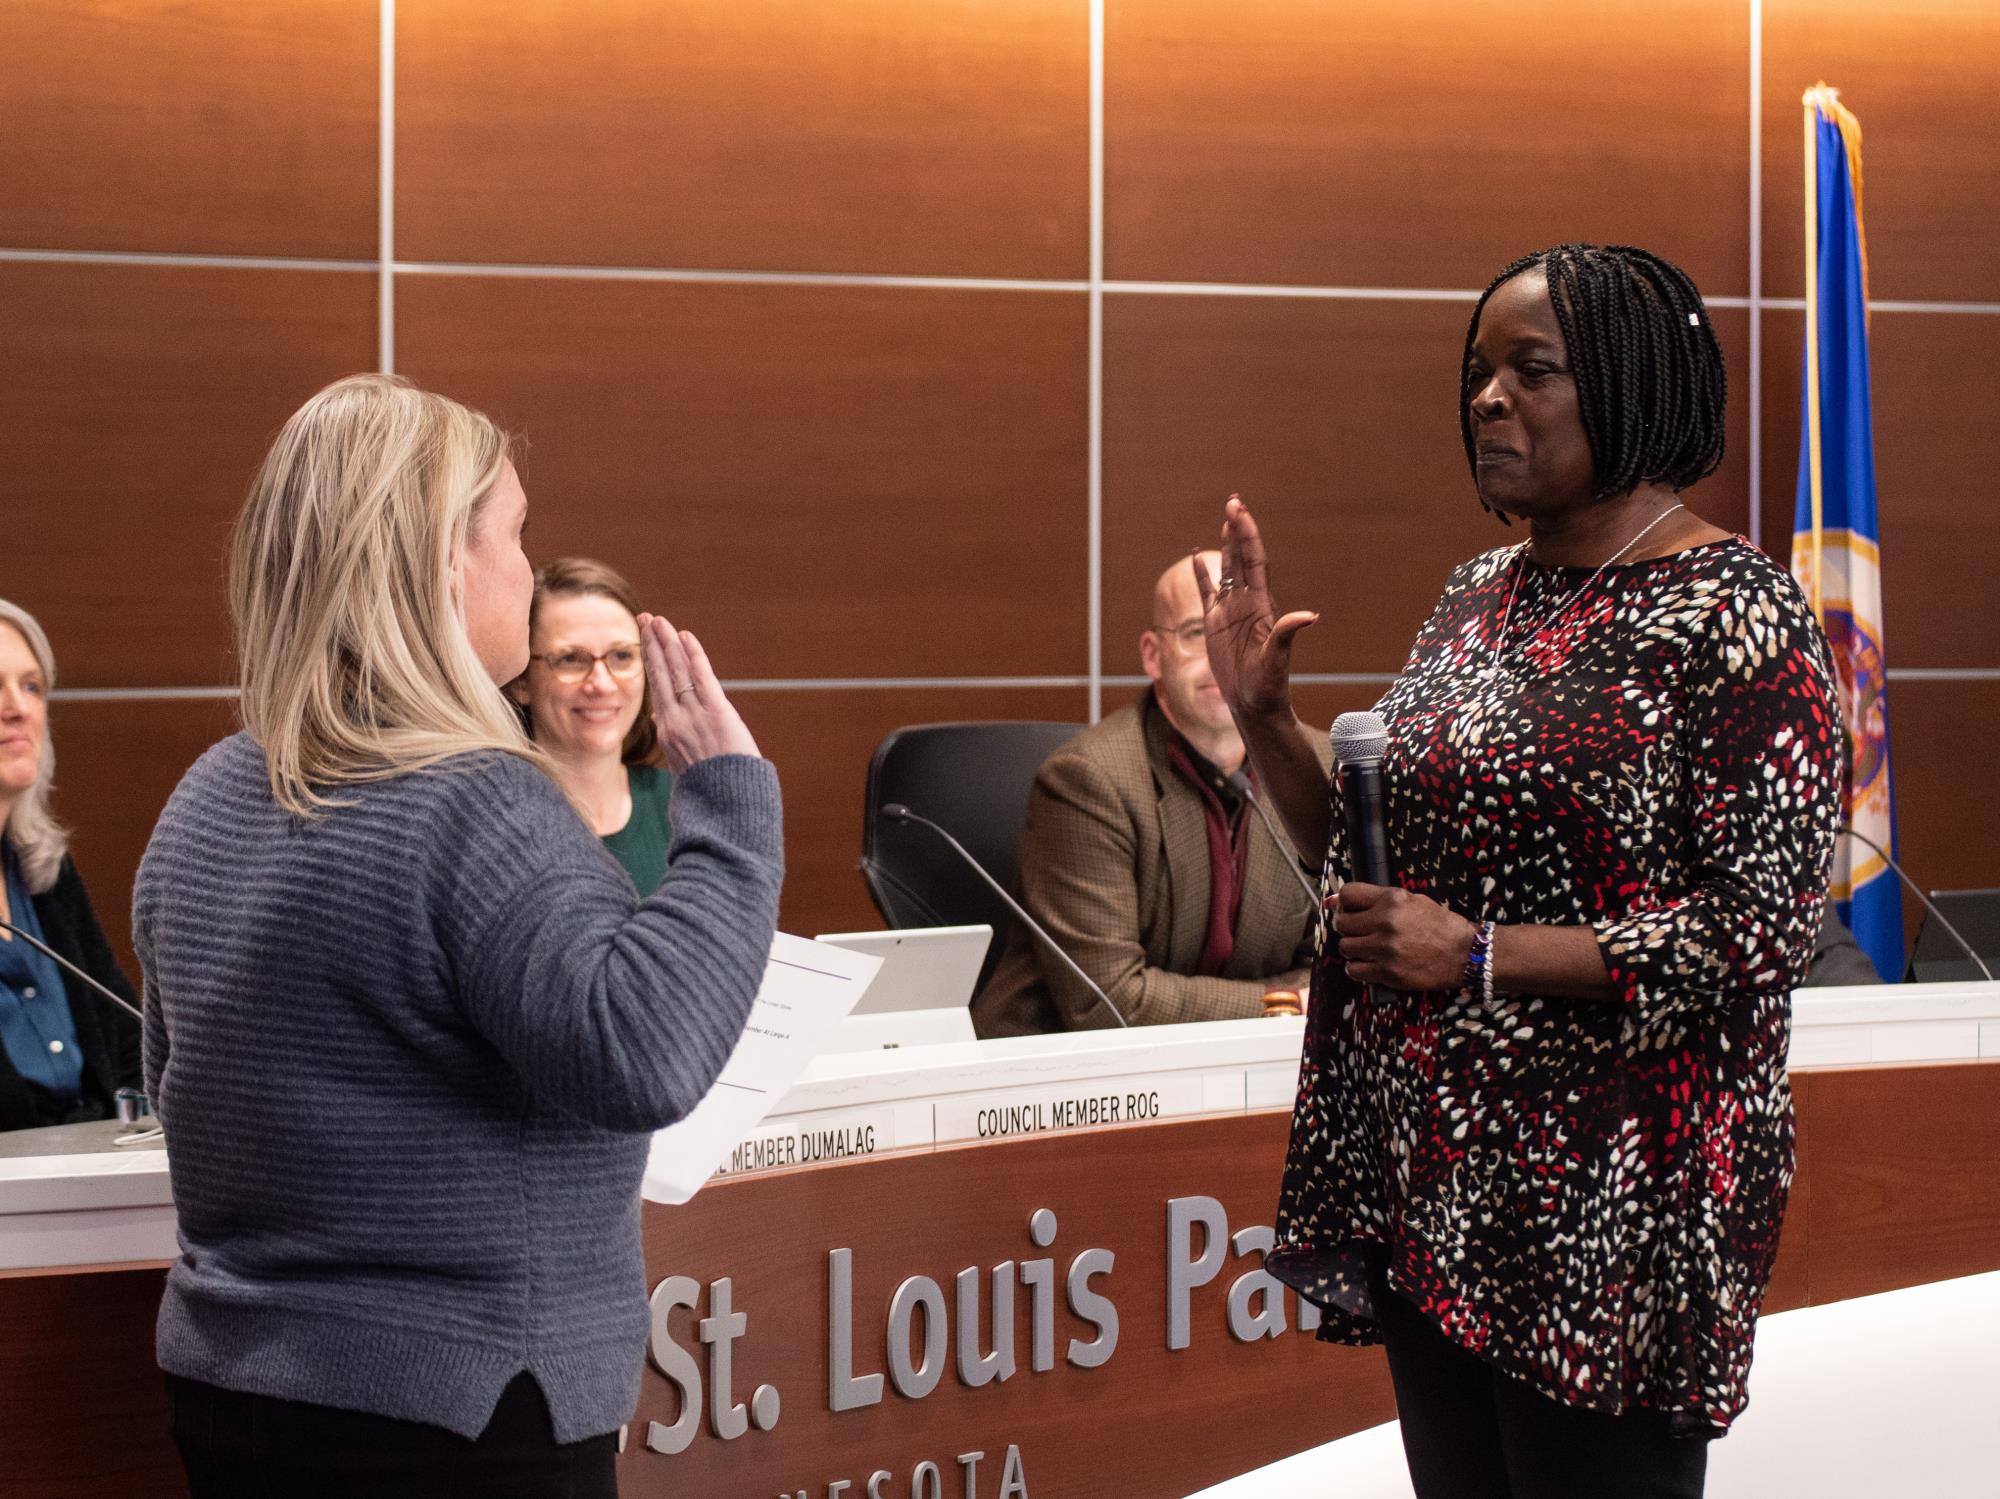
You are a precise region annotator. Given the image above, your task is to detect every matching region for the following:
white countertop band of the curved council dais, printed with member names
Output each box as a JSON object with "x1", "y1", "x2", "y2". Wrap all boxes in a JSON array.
[{"x1": 0, "y1": 983, "x2": 2000, "y2": 1271}]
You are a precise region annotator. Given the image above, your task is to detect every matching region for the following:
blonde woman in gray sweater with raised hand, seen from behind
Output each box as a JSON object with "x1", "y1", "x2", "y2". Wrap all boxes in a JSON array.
[{"x1": 134, "y1": 376, "x2": 782, "y2": 1499}]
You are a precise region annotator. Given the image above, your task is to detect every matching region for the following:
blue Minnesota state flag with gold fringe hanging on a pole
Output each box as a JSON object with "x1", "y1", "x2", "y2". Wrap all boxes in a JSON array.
[{"x1": 1792, "y1": 84, "x2": 1904, "y2": 983}]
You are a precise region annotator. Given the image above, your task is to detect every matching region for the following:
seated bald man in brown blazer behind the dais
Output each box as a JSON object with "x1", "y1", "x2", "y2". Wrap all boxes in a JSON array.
[{"x1": 972, "y1": 552, "x2": 1332, "y2": 1035}]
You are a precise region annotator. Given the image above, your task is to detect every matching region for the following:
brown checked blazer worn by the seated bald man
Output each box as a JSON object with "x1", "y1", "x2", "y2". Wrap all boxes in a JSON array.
[{"x1": 972, "y1": 690, "x2": 1332, "y2": 1035}]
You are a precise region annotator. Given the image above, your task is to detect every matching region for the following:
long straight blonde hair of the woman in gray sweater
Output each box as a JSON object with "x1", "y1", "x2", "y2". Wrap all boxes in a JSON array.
[{"x1": 230, "y1": 374, "x2": 548, "y2": 815}]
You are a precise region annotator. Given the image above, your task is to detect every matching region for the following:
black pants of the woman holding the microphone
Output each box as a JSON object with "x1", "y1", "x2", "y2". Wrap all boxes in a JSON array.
[{"x1": 1374, "y1": 1281, "x2": 1708, "y2": 1499}]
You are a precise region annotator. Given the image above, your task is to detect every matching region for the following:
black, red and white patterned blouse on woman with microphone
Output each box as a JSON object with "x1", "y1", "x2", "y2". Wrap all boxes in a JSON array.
[{"x1": 1268, "y1": 538, "x2": 1842, "y2": 1435}]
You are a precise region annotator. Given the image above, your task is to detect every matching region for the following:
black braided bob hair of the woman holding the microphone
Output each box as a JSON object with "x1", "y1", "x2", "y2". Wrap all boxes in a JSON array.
[{"x1": 1458, "y1": 244, "x2": 1728, "y2": 500}]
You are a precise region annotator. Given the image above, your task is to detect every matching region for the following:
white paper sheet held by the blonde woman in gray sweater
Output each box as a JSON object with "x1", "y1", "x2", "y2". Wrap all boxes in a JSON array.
[{"x1": 640, "y1": 931, "x2": 882, "y2": 1203}]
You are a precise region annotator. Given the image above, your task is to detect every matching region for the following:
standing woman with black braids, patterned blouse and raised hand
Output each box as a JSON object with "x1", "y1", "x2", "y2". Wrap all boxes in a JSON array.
[{"x1": 1196, "y1": 244, "x2": 1840, "y2": 1499}]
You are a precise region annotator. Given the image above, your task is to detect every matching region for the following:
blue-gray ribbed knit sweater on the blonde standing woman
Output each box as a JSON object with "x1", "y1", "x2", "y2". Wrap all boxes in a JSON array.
[{"x1": 134, "y1": 734, "x2": 782, "y2": 1441}]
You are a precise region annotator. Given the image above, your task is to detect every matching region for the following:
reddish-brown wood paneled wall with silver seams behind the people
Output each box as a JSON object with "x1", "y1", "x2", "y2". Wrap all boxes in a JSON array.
[{"x1": 0, "y1": 0, "x2": 2000, "y2": 975}]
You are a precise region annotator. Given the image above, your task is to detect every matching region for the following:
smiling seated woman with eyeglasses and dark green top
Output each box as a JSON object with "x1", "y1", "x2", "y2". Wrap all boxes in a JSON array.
[{"x1": 508, "y1": 558, "x2": 672, "y2": 895}]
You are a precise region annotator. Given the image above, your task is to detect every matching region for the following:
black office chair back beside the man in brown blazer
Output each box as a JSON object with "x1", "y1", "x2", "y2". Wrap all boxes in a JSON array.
[{"x1": 862, "y1": 722, "x2": 1084, "y2": 999}]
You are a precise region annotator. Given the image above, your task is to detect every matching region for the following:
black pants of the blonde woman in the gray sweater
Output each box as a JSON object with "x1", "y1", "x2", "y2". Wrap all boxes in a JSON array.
[{"x1": 166, "y1": 1373, "x2": 618, "y2": 1499}]
